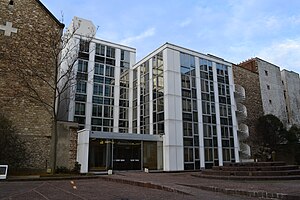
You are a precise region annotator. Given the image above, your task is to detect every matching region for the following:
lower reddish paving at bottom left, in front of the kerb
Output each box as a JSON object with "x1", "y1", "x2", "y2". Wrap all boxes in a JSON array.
[{"x1": 0, "y1": 178, "x2": 256, "y2": 200}]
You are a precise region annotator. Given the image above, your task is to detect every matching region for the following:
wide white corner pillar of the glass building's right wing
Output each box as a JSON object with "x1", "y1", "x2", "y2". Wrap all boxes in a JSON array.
[{"x1": 163, "y1": 49, "x2": 184, "y2": 171}]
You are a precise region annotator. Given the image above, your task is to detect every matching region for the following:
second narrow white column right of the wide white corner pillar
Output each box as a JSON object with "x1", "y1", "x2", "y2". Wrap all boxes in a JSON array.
[{"x1": 212, "y1": 62, "x2": 223, "y2": 166}]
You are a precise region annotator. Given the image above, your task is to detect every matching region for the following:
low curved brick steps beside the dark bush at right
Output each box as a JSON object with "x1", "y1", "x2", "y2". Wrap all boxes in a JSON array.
[{"x1": 196, "y1": 162, "x2": 300, "y2": 180}]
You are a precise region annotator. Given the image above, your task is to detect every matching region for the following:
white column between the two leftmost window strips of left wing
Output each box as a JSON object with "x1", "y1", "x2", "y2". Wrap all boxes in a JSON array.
[{"x1": 85, "y1": 42, "x2": 96, "y2": 130}]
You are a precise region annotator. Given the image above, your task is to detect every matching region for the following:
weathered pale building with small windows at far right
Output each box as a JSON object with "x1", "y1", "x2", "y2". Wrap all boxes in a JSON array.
[{"x1": 235, "y1": 58, "x2": 300, "y2": 127}]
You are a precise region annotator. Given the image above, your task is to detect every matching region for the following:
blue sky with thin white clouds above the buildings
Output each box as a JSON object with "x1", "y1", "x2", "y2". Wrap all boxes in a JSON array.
[{"x1": 42, "y1": 0, "x2": 300, "y2": 73}]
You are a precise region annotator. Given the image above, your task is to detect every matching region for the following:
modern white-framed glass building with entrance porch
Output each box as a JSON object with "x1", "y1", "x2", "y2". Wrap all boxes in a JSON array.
[{"x1": 63, "y1": 19, "x2": 244, "y2": 173}]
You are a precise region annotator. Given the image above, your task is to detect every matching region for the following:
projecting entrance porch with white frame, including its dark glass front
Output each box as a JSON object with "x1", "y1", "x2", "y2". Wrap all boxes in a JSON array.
[{"x1": 77, "y1": 130, "x2": 163, "y2": 173}]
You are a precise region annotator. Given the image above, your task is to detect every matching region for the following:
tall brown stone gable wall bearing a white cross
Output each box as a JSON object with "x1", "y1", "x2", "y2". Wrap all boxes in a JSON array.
[{"x1": 0, "y1": 0, "x2": 76, "y2": 170}]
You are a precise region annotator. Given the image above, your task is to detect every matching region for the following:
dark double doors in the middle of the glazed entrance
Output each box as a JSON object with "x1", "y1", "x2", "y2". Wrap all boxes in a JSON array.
[{"x1": 113, "y1": 140, "x2": 141, "y2": 170}]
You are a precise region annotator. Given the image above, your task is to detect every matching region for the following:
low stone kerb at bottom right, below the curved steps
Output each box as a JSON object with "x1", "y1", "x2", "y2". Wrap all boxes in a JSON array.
[{"x1": 178, "y1": 184, "x2": 300, "y2": 200}]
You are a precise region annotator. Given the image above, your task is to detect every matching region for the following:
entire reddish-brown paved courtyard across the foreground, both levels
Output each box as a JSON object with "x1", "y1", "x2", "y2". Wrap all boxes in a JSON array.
[{"x1": 0, "y1": 172, "x2": 300, "y2": 200}]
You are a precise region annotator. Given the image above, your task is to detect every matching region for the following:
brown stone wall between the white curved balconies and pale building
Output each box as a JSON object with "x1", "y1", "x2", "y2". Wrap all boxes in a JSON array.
[{"x1": 232, "y1": 65, "x2": 264, "y2": 141}]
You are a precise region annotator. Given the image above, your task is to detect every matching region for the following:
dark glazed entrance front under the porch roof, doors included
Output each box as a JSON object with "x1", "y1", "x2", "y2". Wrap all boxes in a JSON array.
[{"x1": 88, "y1": 138, "x2": 163, "y2": 171}]
